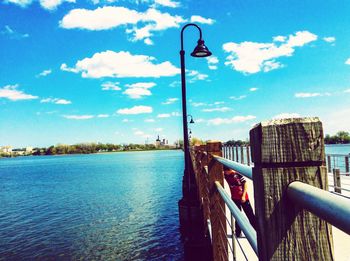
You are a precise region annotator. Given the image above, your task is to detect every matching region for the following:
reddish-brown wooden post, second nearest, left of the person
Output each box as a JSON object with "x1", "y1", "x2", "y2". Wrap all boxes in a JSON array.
[{"x1": 207, "y1": 141, "x2": 228, "y2": 261}]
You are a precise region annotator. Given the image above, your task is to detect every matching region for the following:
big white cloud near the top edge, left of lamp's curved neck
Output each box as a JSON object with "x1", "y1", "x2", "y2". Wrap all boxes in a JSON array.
[{"x1": 60, "y1": 6, "x2": 186, "y2": 44}]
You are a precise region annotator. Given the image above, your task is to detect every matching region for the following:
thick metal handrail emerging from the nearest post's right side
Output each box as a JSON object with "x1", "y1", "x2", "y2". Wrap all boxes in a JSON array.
[{"x1": 287, "y1": 181, "x2": 350, "y2": 234}]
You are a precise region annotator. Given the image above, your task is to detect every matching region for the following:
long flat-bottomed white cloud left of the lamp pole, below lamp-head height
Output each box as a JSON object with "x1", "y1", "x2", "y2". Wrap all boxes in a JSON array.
[{"x1": 61, "y1": 51, "x2": 180, "y2": 78}]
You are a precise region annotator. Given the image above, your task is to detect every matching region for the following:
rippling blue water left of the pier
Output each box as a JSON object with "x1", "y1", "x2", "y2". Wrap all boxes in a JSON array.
[{"x1": 0, "y1": 151, "x2": 183, "y2": 260}]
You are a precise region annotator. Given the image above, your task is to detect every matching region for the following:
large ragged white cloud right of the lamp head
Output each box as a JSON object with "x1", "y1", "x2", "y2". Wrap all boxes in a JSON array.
[{"x1": 222, "y1": 31, "x2": 317, "y2": 74}]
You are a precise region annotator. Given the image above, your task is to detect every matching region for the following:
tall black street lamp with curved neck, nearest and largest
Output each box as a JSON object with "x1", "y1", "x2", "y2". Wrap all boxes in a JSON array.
[{"x1": 180, "y1": 24, "x2": 211, "y2": 198}]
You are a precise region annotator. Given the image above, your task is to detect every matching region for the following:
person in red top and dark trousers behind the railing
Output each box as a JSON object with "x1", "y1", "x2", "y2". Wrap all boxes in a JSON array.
[{"x1": 224, "y1": 166, "x2": 256, "y2": 237}]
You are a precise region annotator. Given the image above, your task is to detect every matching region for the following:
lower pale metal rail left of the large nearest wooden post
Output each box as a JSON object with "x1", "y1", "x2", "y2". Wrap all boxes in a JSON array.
[{"x1": 215, "y1": 181, "x2": 258, "y2": 255}]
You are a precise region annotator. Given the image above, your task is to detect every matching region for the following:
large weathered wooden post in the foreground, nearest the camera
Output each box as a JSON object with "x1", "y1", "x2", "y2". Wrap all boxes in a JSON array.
[{"x1": 250, "y1": 118, "x2": 336, "y2": 261}]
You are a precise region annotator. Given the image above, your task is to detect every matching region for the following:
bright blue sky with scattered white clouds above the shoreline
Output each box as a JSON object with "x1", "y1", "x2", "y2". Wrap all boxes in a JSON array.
[{"x1": 0, "y1": 0, "x2": 350, "y2": 147}]
